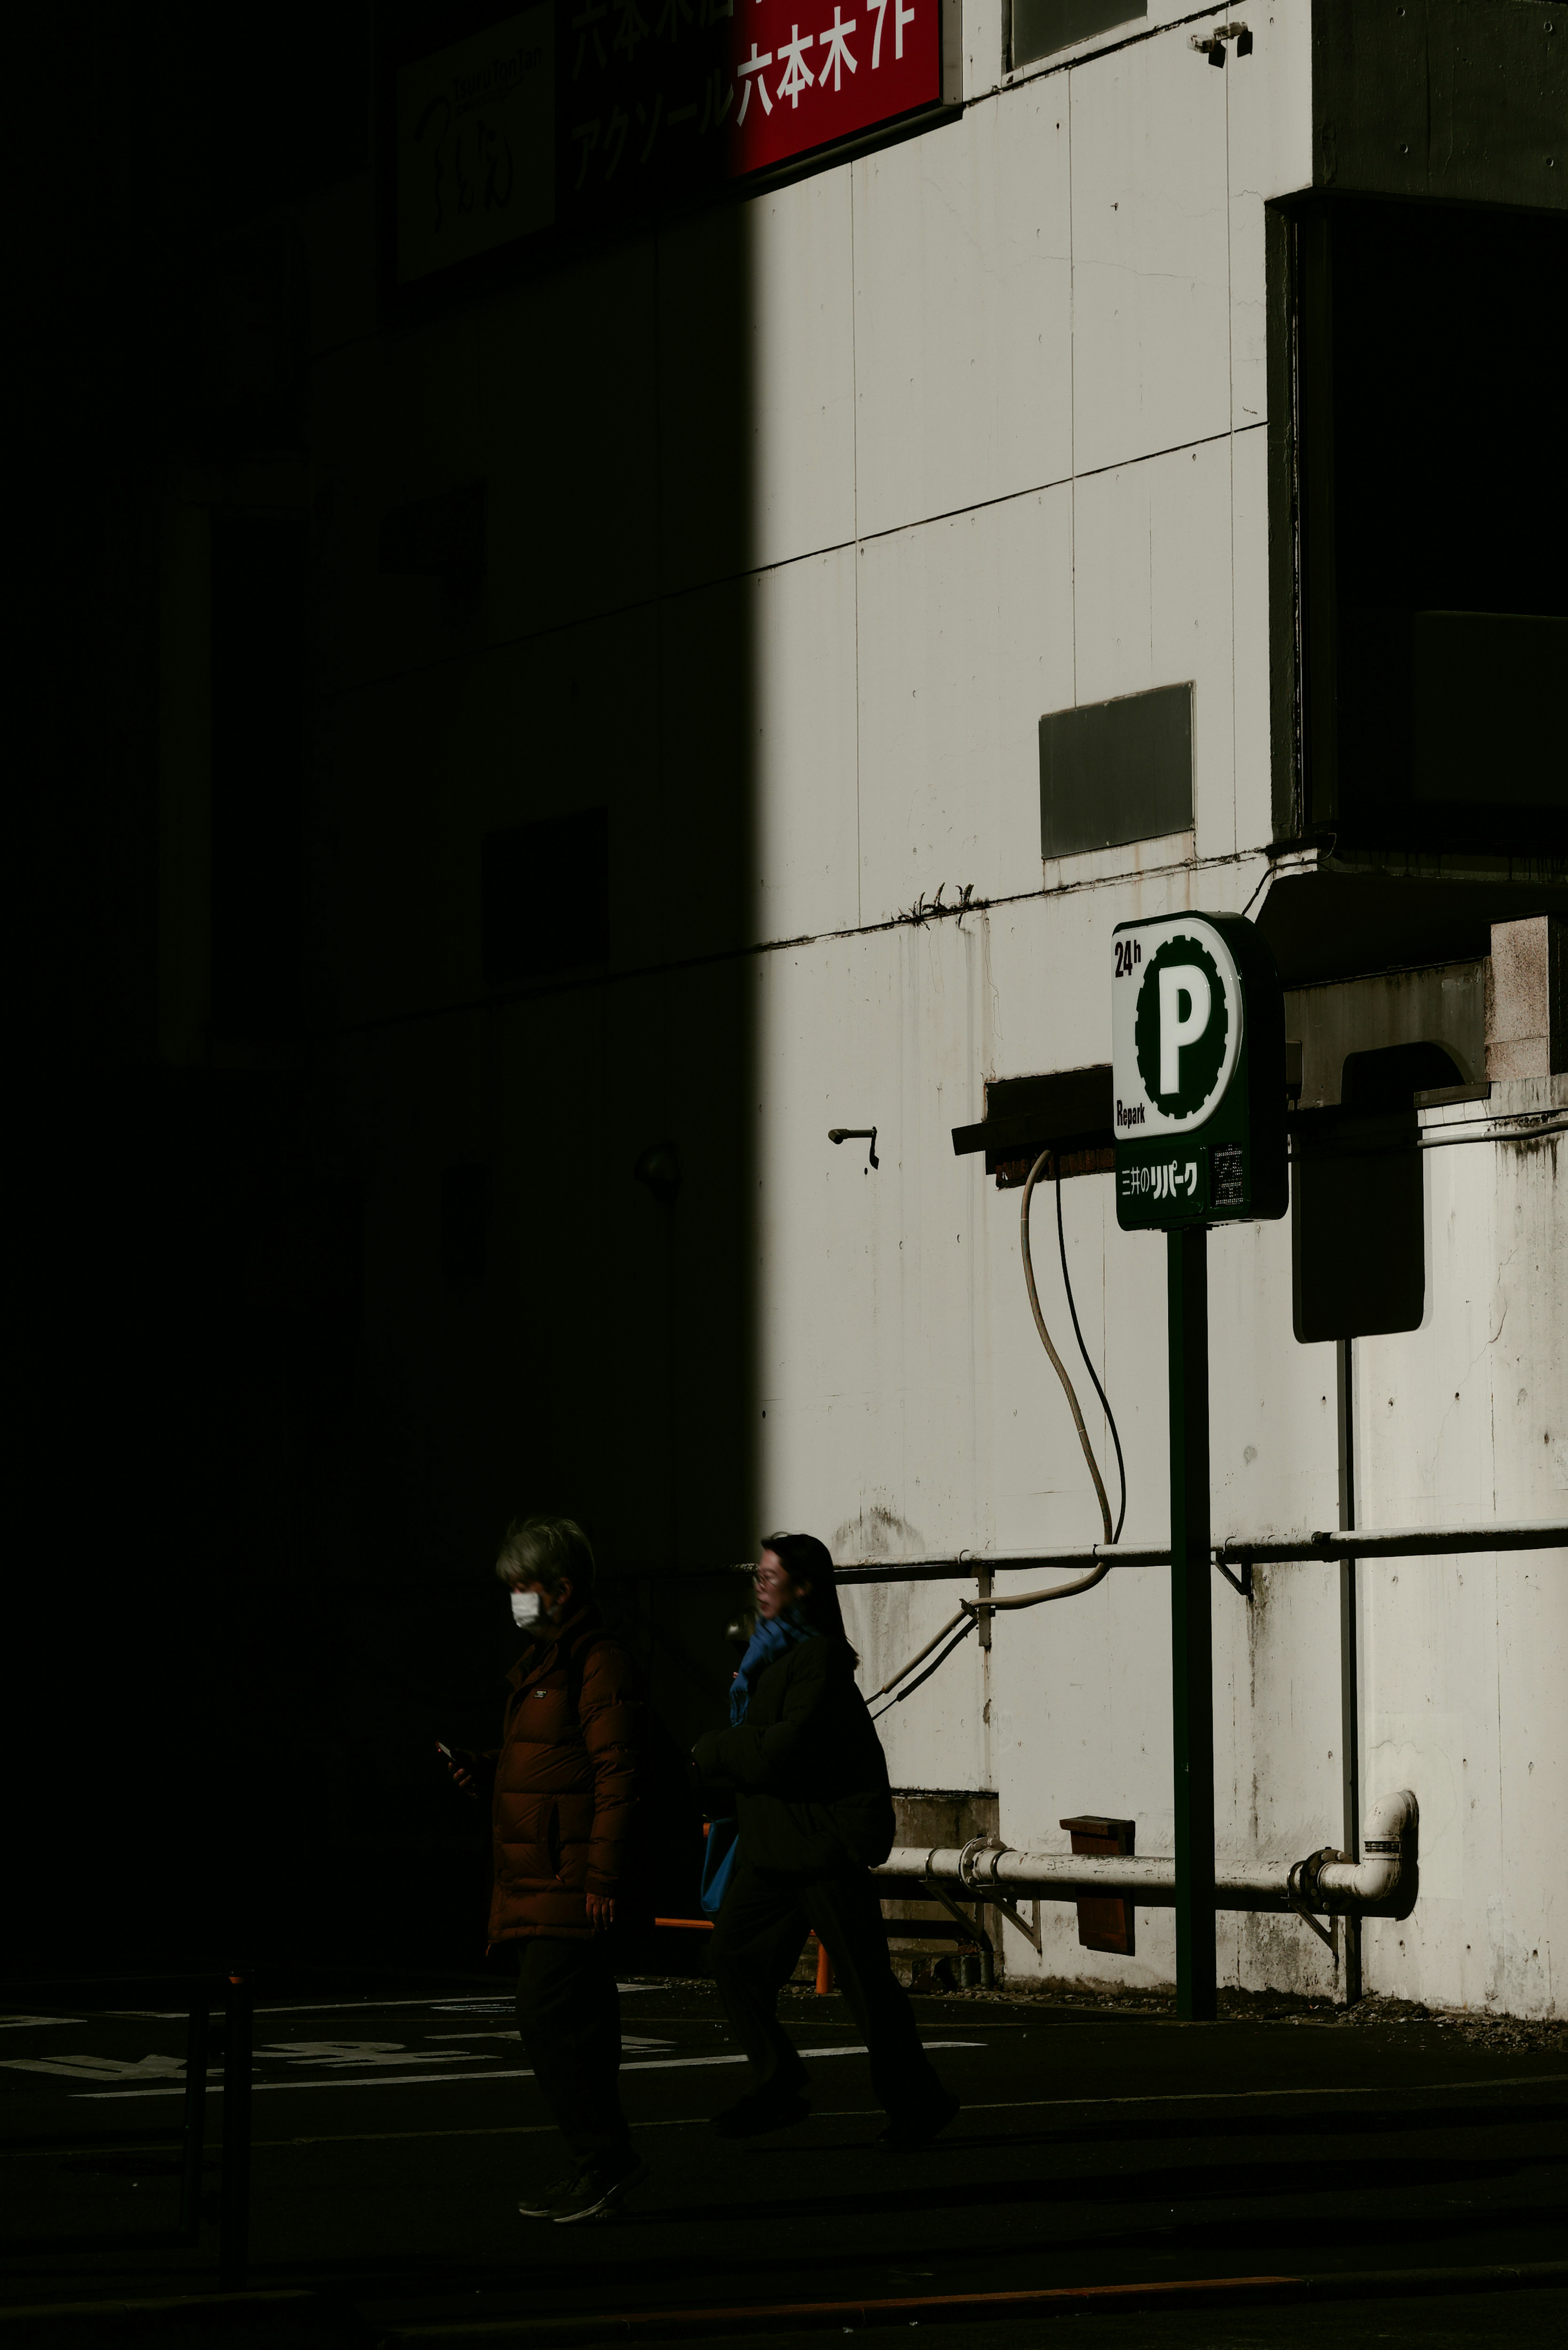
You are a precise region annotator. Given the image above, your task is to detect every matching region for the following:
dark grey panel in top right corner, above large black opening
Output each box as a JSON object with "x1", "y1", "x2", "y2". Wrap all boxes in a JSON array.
[{"x1": 1312, "y1": 0, "x2": 1568, "y2": 212}]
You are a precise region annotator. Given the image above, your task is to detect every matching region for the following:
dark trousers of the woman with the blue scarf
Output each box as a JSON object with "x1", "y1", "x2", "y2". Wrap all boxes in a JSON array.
[{"x1": 712, "y1": 1859, "x2": 943, "y2": 2122}]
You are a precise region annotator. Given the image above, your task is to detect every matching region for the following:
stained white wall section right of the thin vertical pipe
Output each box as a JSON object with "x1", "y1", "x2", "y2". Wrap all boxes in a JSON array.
[{"x1": 1356, "y1": 1109, "x2": 1568, "y2": 2014}]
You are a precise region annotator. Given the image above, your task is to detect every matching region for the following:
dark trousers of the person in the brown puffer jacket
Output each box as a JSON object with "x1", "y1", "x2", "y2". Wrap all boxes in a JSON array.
[{"x1": 517, "y1": 1934, "x2": 630, "y2": 2164}]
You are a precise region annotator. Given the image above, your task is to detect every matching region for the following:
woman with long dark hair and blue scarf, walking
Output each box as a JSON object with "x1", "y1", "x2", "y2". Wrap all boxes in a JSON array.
[{"x1": 693, "y1": 1534, "x2": 959, "y2": 2150}]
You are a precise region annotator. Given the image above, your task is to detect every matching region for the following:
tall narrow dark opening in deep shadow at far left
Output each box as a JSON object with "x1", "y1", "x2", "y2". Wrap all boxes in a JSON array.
[{"x1": 212, "y1": 515, "x2": 305, "y2": 1039}]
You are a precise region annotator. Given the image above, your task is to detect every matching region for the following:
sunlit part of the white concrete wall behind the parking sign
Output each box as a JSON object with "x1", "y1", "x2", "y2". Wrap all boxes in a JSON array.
[{"x1": 728, "y1": 7, "x2": 1568, "y2": 2014}]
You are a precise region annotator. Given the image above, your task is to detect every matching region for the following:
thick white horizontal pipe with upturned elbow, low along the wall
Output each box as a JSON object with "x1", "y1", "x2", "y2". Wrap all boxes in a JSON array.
[{"x1": 872, "y1": 1788, "x2": 1420, "y2": 1917}]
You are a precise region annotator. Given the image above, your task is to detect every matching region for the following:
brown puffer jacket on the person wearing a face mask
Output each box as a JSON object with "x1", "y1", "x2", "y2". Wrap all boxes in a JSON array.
[{"x1": 489, "y1": 1608, "x2": 649, "y2": 1941}]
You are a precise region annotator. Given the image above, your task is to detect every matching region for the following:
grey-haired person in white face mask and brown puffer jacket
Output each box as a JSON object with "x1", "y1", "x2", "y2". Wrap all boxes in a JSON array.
[{"x1": 449, "y1": 1518, "x2": 649, "y2": 2225}]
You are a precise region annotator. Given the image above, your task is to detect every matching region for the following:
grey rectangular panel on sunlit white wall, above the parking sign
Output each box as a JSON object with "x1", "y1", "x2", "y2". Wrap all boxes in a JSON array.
[{"x1": 1039, "y1": 684, "x2": 1192, "y2": 858}]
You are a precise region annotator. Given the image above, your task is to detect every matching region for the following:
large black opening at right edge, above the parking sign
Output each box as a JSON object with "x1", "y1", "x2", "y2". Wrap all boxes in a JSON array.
[{"x1": 1274, "y1": 200, "x2": 1568, "y2": 855}]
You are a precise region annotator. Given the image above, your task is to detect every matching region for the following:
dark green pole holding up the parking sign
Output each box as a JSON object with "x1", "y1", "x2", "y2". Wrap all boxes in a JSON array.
[{"x1": 1166, "y1": 1224, "x2": 1215, "y2": 2023}]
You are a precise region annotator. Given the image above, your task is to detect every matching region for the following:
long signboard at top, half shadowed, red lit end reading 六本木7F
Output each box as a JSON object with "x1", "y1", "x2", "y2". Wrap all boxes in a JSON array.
[{"x1": 383, "y1": 0, "x2": 962, "y2": 284}]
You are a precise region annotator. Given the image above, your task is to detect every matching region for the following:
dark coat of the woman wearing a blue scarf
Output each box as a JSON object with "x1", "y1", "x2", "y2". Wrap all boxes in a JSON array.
[{"x1": 693, "y1": 1640, "x2": 893, "y2": 1875}]
